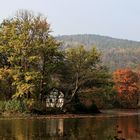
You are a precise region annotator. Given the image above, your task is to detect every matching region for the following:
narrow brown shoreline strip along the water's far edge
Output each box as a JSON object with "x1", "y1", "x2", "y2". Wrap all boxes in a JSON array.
[{"x1": 0, "y1": 109, "x2": 140, "y2": 119}]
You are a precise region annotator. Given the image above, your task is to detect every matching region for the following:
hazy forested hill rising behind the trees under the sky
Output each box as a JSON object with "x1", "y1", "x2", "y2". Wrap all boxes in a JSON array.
[{"x1": 57, "y1": 34, "x2": 140, "y2": 71}]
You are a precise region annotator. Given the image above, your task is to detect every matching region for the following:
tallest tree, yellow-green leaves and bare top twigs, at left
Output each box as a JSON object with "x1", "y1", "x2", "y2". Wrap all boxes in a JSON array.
[{"x1": 0, "y1": 11, "x2": 62, "y2": 99}]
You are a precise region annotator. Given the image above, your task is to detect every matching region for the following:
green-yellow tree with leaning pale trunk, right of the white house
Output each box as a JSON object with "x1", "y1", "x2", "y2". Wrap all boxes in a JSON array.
[{"x1": 60, "y1": 45, "x2": 109, "y2": 109}]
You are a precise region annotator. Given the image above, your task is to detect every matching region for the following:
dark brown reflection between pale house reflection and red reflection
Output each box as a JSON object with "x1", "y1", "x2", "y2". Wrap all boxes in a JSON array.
[{"x1": 65, "y1": 118, "x2": 115, "y2": 140}]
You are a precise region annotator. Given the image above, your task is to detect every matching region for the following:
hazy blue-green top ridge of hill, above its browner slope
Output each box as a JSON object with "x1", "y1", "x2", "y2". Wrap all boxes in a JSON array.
[{"x1": 56, "y1": 34, "x2": 140, "y2": 48}]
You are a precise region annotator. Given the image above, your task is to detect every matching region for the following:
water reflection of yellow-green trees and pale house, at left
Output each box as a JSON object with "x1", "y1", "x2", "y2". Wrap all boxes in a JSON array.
[{"x1": 0, "y1": 119, "x2": 64, "y2": 140}]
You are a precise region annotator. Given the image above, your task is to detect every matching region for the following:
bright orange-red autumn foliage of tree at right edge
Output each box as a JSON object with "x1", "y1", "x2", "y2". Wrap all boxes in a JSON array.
[{"x1": 113, "y1": 69, "x2": 139, "y2": 98}]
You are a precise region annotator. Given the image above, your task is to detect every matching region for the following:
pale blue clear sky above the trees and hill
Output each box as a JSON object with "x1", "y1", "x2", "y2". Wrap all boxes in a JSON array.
[{"x1": 0, "y1": 0, "x2": 140, "y2": 41}]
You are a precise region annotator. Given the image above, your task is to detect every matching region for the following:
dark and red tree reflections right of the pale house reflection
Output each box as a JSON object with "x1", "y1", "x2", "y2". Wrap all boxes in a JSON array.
[{"x1": 64, "y1": 116, "x2": 140, "y2": 140}]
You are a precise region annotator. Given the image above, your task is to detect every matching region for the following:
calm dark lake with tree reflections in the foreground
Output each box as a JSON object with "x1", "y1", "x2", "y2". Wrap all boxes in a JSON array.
[{"x1": 0, "y1": 110, "x2": 140, "y2": 140}]
